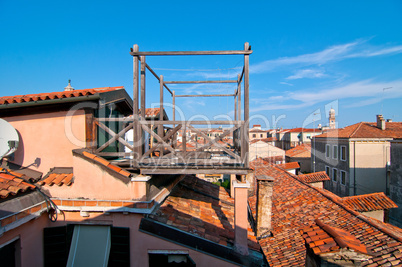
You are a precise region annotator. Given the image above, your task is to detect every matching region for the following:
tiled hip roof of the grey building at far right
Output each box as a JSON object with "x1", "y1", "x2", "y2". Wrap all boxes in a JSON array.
[{"x1": 316, "y1": 122, "x2": 402, "y2": 138}]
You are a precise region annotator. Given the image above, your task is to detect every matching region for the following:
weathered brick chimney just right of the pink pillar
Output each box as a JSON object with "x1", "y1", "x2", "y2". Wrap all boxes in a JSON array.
[{"x1": 256, "y1": 175, "x2": 274, "y2": 238}]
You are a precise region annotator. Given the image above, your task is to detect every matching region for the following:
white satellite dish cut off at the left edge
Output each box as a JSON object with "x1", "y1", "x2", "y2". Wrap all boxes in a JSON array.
[{"x1": 0, "y1": 119, "x2": 20, "y2": 159}]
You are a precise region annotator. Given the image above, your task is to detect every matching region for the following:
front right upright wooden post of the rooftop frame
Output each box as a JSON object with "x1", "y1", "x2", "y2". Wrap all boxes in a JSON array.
[{"x1": 241, "y1": 42, "x2": 250, "y2": 168}]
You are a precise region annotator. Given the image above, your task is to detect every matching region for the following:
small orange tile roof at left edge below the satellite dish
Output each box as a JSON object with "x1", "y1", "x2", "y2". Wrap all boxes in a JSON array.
[{"x1": 0, "y1": 168, "x2": 36, "y2": 198}]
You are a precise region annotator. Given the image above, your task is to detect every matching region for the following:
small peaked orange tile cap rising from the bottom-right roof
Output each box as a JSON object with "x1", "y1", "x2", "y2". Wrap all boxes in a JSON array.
[{"x1": 300, "y1": 219, "x2": 367, "y2": 255}]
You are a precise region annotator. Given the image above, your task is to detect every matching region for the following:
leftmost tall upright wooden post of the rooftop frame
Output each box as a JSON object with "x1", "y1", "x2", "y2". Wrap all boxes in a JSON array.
[{"x1": 133, "y1": 44, "x2": 141, "y2": 165}]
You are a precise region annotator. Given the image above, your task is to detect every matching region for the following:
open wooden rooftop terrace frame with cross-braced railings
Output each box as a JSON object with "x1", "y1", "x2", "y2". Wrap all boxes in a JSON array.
[{"x1": 95, "y1": 43, "x2": 252, "y2": 175}]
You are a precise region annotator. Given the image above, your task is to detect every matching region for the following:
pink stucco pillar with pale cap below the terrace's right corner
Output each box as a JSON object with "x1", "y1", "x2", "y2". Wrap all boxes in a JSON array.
[{"x1": 232, "y1": 180, "x2": 250, "y2": 255}]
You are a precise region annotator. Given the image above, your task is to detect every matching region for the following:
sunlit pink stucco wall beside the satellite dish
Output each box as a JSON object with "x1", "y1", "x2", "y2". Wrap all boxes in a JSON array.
[{"x1": 3, "y1": 110, "x2": 85, "y2": 174}]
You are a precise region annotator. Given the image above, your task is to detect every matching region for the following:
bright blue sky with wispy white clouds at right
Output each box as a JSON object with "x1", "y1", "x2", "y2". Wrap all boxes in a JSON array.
[{"x1": 0, "y1": 0, "x2": 402, "y2": 128}]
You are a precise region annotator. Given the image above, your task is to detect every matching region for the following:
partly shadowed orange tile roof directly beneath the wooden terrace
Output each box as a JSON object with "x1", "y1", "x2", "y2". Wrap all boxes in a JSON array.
[{"x1": 150, "y1": 175, "x2": 259, "y2": 250}]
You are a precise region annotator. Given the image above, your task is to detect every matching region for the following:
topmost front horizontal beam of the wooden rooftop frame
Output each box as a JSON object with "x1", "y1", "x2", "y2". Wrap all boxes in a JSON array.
[{"x1": 130, "y1": 50, "x2": 253, "y2": 56}]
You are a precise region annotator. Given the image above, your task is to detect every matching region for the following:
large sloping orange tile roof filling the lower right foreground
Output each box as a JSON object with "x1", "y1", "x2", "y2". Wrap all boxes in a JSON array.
[{"x1": 249, "y1": 159, "x2": 402, "y2": 266}]
